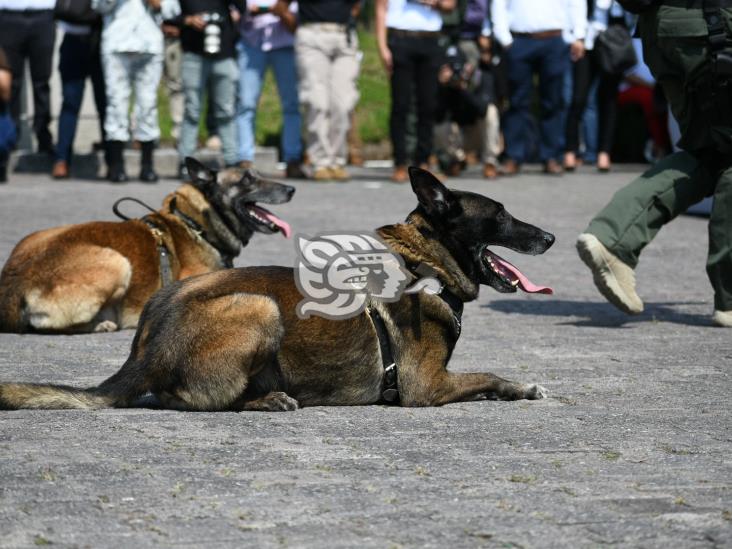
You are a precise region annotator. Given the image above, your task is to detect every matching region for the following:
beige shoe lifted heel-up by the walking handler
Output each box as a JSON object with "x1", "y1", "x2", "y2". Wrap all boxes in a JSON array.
[{"x1": 577, "y1": 233, "x2": 643, "y2": 315}]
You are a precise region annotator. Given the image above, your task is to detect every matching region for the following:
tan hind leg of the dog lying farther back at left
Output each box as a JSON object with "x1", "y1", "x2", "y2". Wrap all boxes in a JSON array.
[{"x1": 23, "y1": 245, "x2": 132, "y2": 332}]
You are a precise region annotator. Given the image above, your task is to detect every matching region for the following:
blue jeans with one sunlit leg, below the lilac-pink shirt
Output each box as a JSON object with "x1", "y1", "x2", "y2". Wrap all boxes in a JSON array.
[{"x1": 236, "y1": 42, "x2": 302, "y2": 162}]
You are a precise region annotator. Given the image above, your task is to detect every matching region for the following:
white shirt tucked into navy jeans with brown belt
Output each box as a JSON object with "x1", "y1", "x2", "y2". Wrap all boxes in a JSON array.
[{"x1": 491, "y1": 0, "x2": 587, "y2": 46}]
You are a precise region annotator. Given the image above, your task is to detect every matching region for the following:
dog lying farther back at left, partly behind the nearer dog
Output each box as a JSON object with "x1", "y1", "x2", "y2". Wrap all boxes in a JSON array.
[{"x1": 0, "y1": 158, "x2": 295, "y2": 333}]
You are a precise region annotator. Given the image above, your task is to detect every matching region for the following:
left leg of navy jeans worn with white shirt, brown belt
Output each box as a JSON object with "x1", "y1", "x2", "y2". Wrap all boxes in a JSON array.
[{"x1": 503, "y1": 36, "x2": 536, "y2": 165}]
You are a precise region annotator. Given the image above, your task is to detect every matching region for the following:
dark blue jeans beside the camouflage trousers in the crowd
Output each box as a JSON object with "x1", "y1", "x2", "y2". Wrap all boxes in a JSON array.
[{"x1": 56, "y1": 33, "x2": 107, "y2": 162}]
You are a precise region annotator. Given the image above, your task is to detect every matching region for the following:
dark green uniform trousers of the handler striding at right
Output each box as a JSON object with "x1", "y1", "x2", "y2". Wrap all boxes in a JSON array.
[{"x1": 587, "y1": 6, "x2": 732, "y2": 311}]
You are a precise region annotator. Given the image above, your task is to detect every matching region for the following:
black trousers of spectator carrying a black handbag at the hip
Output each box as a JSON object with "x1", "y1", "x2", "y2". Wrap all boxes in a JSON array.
[{"x1": 566, "y1": 51, "x2": 623, "y2": 153}]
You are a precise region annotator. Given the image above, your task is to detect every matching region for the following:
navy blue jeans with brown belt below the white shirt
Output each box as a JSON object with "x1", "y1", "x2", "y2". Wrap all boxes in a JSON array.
[{"x1": 503, "y1": 36, "x2": 569, "y2": 164}]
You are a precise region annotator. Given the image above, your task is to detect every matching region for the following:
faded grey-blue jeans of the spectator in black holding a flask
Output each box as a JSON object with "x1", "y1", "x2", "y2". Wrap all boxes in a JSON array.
[{"x1": 178, "y1": 52, "x2": 239, "y2": 166}]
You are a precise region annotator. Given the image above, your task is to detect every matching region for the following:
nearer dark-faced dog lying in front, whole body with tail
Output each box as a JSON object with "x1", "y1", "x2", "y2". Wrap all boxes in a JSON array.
[{"x1": 0, "y1": 168, "x2": 554, "y2": 411}]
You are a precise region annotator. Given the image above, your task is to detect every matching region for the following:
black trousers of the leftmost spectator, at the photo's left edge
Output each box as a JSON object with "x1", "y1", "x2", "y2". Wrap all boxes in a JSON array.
[{"x1": 0, "y1": 10, "x2": 56, "y2": 148}]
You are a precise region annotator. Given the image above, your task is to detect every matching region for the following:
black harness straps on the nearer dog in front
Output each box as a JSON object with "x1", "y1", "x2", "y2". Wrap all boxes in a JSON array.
[{"x1": 367, "y1": 263, "x2": 463, "y2": 404}]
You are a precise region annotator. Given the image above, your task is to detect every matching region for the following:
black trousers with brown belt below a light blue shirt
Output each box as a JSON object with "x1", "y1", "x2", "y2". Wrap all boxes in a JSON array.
[{"x1": 388, "y1": 32, "x2": 442, "y2": 166}]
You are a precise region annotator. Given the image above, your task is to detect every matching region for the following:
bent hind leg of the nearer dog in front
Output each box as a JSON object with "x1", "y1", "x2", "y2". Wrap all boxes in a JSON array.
[{"x1": 152, "y1": 294, "x2": 288, "y2": 411}]
